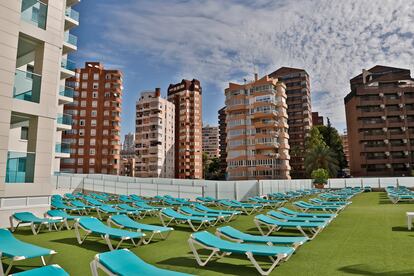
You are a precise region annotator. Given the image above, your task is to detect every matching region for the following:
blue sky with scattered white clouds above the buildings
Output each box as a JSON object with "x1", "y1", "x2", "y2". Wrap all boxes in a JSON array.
[{"x1": 71, "y1": 0, "x2": 414, "y2": 138}]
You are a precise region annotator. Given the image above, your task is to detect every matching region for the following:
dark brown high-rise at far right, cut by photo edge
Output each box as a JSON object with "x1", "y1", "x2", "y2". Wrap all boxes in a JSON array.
[{"x1": 345, "y1": 65, "x2": 414, "y2": 176}]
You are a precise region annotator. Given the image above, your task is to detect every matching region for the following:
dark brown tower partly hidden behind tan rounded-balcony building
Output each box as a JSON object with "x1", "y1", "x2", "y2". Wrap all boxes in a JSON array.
[{"x1": 269, "y1": 67, "x2": 312, "y2": 178}]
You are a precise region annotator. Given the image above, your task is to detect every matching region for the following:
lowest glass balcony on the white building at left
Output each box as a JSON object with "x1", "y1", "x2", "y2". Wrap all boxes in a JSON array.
[{"x1": 6, "y1": 151, "x2": 36, "y2": 183}]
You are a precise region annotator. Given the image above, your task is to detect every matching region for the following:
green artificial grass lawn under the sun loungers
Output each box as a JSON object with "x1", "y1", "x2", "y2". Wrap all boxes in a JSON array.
[{"x1": 6, "y1": 193, "x2": 414, "y2": 275}]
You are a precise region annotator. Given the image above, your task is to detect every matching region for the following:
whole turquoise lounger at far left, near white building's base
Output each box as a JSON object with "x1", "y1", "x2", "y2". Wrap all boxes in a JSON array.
[{"x1": 9, "y1": 212, "x2": 63, "y2": 235}]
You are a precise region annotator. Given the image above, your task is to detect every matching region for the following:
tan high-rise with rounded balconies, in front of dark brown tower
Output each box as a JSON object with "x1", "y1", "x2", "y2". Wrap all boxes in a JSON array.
[{"x1": 225, "y1": 75, "x2": 290, "y2": 180}]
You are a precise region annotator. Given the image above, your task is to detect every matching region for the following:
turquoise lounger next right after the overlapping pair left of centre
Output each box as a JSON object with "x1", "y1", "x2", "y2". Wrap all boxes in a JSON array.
[{"x1": 159, "y1": 208, "x2": 215, "y2": 231}]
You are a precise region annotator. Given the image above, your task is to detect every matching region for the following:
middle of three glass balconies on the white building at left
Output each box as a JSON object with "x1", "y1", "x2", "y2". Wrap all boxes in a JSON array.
[{"x1": 13, "y1": 69, "x2": 42, "y2": 103}]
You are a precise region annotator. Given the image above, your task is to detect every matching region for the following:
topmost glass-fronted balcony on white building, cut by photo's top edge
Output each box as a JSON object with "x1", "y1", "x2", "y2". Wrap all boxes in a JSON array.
[{"x1": 21, "y1": 0, "x2": 47, "y2": 30}]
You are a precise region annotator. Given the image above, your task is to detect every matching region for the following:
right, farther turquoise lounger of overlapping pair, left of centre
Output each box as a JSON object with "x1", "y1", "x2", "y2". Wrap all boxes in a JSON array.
[{"x1": 107, "y1": 215, "x2": 174, "y2": 244}]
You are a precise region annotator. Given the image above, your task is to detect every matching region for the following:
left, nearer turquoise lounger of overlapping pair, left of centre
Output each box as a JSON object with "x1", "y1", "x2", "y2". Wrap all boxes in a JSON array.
[{"x1": 75, "y1": 217, "x2": 145, "y2": 250}]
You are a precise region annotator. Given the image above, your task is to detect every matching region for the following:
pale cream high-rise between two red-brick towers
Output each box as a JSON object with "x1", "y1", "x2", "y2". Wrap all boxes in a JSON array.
[{"x1": 135, "y1": 88, "x2": 175, "y2": 178}]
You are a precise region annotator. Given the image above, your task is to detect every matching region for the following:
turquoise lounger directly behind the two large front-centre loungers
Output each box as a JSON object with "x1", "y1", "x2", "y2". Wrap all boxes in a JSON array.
[{"x1": 254, "y1": 215, "x2": 326, "y2": 240}]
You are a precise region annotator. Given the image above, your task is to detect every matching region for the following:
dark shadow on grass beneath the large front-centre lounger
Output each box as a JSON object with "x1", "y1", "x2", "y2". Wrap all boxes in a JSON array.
[{"x1": 158, "y1": 255, "x2": 257, "y2": 276}]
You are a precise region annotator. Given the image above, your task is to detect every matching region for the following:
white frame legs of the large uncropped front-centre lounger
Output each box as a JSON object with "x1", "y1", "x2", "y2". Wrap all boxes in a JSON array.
[{"x1": 188, "y1": 235, "x2": 292, "y2": 275}]
